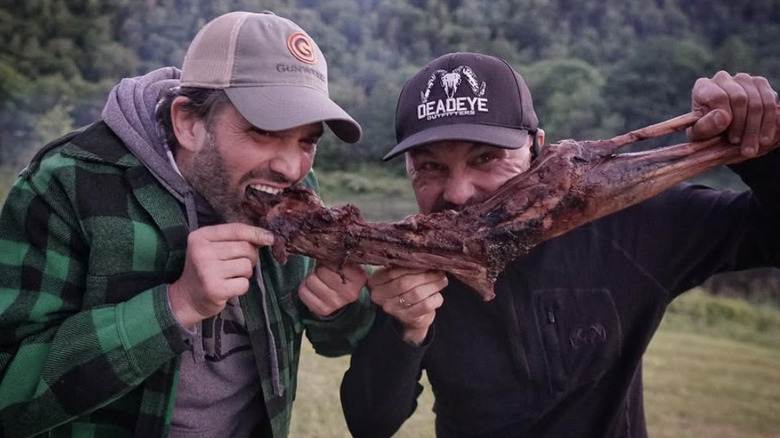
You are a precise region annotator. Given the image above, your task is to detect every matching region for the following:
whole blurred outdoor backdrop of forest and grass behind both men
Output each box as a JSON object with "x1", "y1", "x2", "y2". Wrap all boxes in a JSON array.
[{"x1": 0, "y1": 0, "x2": 780, "y2": 437}]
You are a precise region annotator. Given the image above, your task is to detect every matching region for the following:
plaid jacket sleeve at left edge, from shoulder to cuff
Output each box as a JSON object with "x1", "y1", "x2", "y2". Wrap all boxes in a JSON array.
[{"x1": 0, "y1": 150, "x2": 184, "y2": 437}]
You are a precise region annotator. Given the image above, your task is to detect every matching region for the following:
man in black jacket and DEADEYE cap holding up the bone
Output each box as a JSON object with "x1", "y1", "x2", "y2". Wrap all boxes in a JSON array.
[{"x1": 341, "y1": 53, "x2": 780, "y2": 438}]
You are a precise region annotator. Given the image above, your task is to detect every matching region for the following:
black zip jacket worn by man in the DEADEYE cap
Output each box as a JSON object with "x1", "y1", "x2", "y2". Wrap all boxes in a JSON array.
[{"x1": 341, "y1": 152, "x2": 780, "y2": 438}]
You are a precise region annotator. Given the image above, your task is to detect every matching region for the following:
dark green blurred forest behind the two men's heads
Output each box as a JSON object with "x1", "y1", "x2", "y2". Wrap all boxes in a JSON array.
[{"x1": 0, "y1": 0, "x2": 780, "y2": 177}]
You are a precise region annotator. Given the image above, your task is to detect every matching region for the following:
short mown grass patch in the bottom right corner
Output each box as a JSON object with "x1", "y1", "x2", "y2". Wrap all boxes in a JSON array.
[{"x1": 644, "y1": 330, "x2": 780, "y2": 438}]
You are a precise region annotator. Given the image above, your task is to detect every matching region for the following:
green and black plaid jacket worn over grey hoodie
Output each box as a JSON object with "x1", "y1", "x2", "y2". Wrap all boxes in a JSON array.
[{"x1": 0, "y1": 122, "x2": 373, "y2": 438}]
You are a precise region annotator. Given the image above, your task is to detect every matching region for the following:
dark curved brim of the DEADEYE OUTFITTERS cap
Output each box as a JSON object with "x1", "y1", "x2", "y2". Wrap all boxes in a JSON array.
[{"x1": 383, "y1": 123, "x2": 528, "y2": 161}]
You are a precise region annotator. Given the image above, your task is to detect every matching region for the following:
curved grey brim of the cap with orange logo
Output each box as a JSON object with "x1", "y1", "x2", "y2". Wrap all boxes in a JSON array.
[{"x1": 225, "y1": 86, "x2": 362, "y2": 143}]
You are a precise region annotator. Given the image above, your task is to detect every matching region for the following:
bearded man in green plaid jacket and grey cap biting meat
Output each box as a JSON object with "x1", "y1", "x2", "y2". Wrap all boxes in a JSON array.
[{"x1": 0, "y1": 13, "x2": 373, "y2": 437}]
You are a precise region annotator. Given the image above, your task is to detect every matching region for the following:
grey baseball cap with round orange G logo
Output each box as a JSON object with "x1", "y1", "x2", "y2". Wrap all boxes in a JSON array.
[{"x1": 181, "y1": 12, "x2": 362, "y2": 143}]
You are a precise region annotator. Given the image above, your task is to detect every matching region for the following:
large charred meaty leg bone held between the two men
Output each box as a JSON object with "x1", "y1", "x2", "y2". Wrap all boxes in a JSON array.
[{"x1": 247, "y1": 112, "x2": 772, "y2": 300}]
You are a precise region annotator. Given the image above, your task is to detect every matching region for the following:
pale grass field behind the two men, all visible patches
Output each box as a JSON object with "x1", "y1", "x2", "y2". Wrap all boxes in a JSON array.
[{"x1": 291, "y1": 292, "x2": 780, "y2": 438}]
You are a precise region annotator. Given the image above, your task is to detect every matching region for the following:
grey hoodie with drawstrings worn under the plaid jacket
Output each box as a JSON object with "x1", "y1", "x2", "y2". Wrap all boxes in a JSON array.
[{"x1": 103, "y1": 67, "x2": 274, "y2": 437}]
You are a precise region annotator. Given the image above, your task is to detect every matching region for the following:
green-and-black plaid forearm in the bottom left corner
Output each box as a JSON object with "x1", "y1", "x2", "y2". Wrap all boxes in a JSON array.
[{"x1": 0, "y1": 287, "x2": 184, "y2": 436}]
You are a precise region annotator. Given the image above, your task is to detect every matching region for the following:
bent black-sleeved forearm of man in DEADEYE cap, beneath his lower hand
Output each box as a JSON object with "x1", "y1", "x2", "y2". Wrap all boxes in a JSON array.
[{"x1": 341, "y1": 313, "x2": 433, "y2": 438}]
